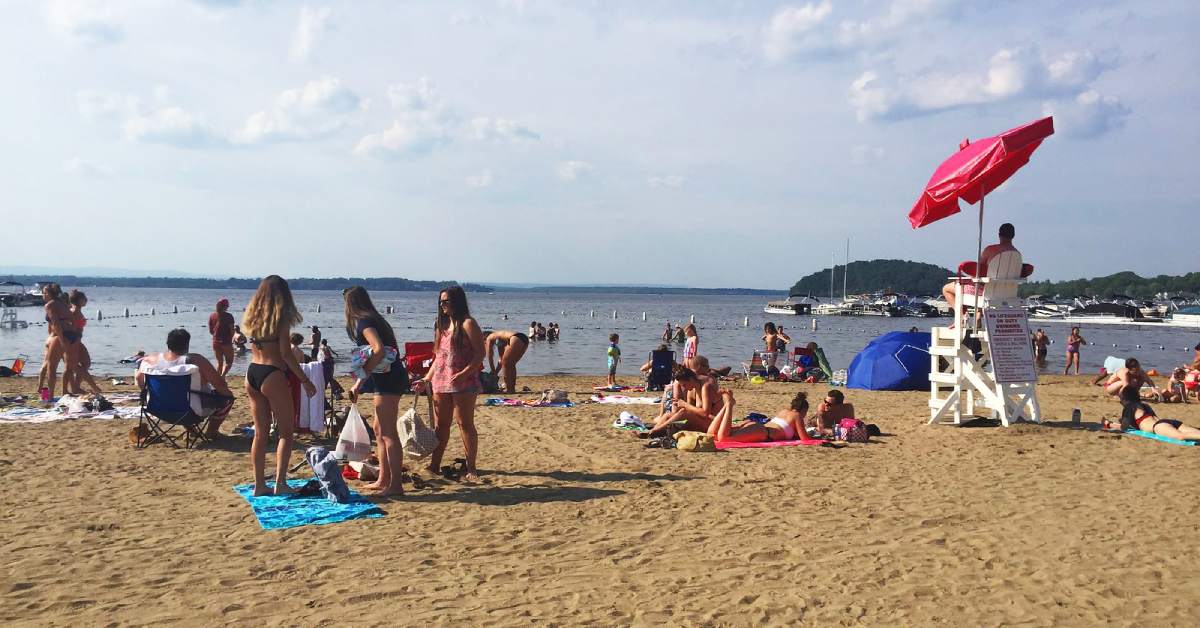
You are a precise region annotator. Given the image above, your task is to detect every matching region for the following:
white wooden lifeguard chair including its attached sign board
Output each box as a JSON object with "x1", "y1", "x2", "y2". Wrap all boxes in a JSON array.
[{"x1": 929, "y1": 251, "x2": 1042, "y2": 427}]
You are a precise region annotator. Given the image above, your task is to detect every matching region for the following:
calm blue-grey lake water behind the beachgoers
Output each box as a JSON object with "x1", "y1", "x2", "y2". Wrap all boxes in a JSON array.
[{"x1": 0, "y1": 288, "x2": 1200, "y2": 379}]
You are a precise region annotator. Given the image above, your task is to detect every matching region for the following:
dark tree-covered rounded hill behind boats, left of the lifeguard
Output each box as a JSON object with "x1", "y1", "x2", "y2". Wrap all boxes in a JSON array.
[{"x1": 790, "y1": 259, "x2": 953, "y2": 297}]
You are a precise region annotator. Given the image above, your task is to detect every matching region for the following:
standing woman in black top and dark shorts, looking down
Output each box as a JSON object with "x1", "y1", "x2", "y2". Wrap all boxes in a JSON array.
[{"x1": 343, "y1": 286, "x2": 408, "y2": 497}]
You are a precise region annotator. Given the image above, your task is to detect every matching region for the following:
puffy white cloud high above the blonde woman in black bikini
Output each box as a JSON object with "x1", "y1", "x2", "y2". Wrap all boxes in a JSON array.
[{"x1": 236, "y1": 77, "x2": 364, "y2": 144}]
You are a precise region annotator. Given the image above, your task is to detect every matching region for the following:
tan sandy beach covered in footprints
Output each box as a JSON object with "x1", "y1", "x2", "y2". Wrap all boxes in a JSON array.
[{"x1": 0, "y1": 376, "x2": 1200, "y2": 626}]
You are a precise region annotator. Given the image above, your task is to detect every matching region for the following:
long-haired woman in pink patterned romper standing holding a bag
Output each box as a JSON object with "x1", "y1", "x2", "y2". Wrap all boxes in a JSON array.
[{"x1": 416, "y1": 286, "x2": 484, "y2": 482}]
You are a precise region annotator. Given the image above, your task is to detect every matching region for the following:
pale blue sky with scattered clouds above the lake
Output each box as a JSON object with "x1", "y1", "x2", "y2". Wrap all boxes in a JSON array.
[{"x1": 0, "y1": 0, "x2": 1200, "y2": 289}]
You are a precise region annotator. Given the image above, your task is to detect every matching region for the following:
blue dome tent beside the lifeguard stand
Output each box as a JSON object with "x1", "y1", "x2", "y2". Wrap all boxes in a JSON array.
[{"x1": 846, "y1": 331, "x2": 930, "y2": 390}]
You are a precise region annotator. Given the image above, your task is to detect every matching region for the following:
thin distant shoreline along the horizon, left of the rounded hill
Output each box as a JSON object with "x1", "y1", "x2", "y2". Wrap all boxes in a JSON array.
[{"x1": 0, "y1": 274, "x2": 787, "y2": 297}]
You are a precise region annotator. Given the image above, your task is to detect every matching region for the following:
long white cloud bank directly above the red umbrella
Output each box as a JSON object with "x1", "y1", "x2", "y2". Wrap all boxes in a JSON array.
[{"x1": 850, "y1": 48, "x2": 1111, "y2": 121}]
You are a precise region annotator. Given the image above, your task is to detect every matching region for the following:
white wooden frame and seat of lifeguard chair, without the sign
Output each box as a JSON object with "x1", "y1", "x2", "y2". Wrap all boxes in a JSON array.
[{"x1": 929, "y1": 251, "x2": 1042, "y2": 427}]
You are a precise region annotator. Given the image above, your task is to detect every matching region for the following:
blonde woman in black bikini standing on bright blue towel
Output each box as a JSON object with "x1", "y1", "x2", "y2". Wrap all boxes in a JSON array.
[{"x1": 241, "y1": 275, "x2": 317, "y2": 496}]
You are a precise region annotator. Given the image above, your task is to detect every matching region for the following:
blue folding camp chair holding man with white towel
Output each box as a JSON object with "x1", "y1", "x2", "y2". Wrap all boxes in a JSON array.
[{"x1": 137, "y1": 373, "x2": 233, "y2": 449}]
